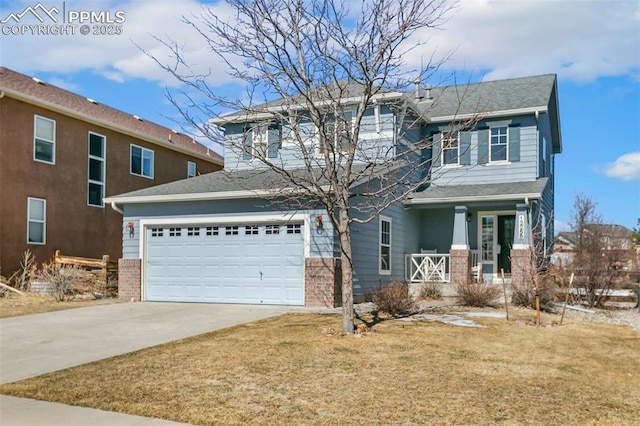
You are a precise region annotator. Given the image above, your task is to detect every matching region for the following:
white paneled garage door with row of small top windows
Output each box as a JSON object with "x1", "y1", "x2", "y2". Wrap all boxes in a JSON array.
[{"x1": 145, "y1": 223, "x2": 304, "y2": 305}]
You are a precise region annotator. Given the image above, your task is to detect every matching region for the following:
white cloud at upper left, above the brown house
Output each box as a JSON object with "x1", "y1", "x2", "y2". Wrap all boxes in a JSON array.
[{"x1": 0, "y1": 0, "x2": 238, "y2": 86}]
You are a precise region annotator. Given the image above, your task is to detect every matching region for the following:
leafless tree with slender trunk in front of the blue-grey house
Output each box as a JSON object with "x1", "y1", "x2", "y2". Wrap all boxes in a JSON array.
[{"x1": 152, "y1": 0, "x2": 477, "y2": 333}]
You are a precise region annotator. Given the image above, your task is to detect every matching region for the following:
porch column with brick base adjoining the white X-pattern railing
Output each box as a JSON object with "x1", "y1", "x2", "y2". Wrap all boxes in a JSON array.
[{"x1": 449, "y1": 206, "x2": 471, "y2": 284}]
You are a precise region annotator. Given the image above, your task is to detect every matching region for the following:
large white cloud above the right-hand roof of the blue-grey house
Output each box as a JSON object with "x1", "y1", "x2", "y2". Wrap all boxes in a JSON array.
[{"x1": 413, "y1": 0, "x2": 640, "y2": 82}]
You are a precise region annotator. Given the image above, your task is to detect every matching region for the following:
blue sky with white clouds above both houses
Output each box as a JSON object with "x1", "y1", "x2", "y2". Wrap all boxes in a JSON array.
[{"x1": 0, "y1": 0, "x2": 640, "y2": 232}]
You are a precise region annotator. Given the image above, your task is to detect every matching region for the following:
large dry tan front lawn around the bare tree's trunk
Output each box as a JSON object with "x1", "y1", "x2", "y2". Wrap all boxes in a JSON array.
[{"x1": 0, "y1": 313, "x2": 640, "y2": 425}]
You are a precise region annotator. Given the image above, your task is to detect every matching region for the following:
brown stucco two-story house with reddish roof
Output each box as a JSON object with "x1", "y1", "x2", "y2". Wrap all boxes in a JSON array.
[{"x1": 0, "y1": 67, "x2": 223, "y2": 276}]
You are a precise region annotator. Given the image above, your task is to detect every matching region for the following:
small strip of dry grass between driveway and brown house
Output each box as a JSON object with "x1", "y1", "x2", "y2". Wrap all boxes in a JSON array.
[{"x1": 0, "y1": 293, "x2": 114, "y2": 318}]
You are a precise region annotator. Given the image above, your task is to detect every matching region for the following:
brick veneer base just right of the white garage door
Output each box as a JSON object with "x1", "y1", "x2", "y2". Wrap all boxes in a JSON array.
[{"x1": 304, "y1": 257, "x2": 342, "y2": 308}]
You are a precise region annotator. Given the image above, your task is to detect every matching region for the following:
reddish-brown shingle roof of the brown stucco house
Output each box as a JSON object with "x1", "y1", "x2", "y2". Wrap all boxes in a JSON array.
[{"x1": 0, "y1": 67, "x2": 222, "y2": 163}]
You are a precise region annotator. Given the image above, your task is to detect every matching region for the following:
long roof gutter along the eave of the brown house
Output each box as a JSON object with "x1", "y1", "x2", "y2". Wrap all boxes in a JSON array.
[{"x1": 2, "y1": 89, "x2": 223, "y2": 166}]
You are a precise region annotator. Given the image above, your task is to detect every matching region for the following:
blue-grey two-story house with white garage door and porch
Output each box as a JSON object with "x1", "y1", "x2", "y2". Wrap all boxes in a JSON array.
[{"x1": 109, "y1": 75, "x2": 562, "y2": 306}]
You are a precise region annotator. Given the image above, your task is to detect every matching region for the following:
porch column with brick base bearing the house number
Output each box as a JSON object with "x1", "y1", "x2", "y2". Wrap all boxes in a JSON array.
[{"x1": 511, "y1": 204, "x2": 533, "y2": 285}]
